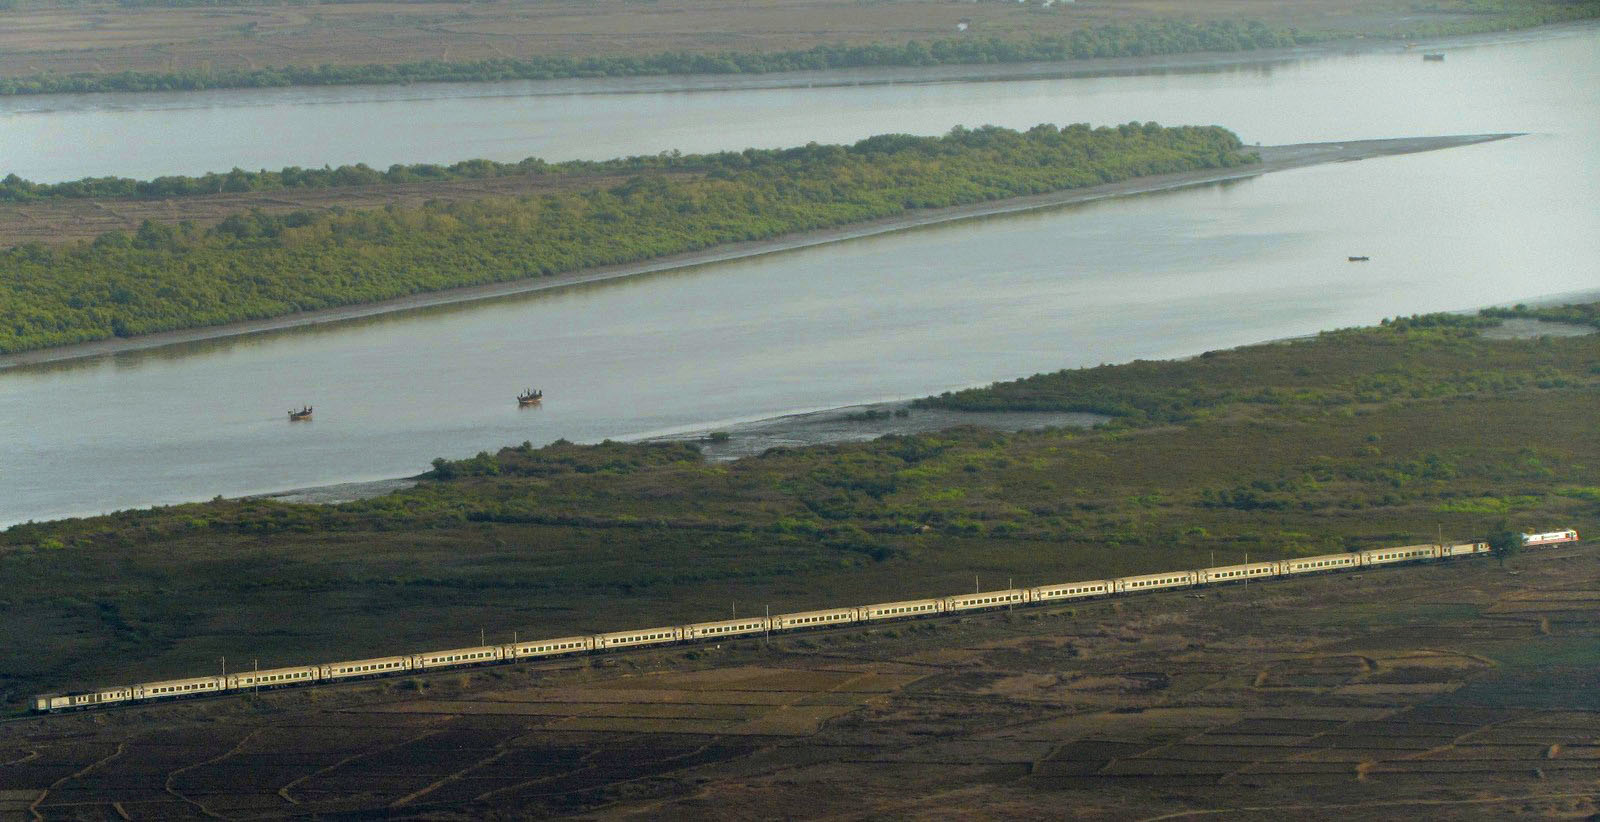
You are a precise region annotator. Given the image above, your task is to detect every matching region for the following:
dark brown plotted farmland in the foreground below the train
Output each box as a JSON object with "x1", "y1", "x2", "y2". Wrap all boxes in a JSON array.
[{"x1": 0, "y1": 549, "x2": 1600, "y2": 820}]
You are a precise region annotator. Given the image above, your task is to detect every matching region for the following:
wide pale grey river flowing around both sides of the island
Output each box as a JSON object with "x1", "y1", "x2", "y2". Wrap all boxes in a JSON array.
[{"x1": 0, "y1": 29, "x2": 1600, "y2": 523}]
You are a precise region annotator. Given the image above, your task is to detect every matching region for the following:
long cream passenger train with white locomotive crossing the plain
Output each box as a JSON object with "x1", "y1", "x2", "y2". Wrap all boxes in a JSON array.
[{"x1": 34, "y1": 529, "x2": 1578, "y2": 712}]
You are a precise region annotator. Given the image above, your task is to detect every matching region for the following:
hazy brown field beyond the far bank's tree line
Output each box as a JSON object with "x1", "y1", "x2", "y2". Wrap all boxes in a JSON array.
[{"x1": 0, "y1": 0, "x2": 1459, "y2": 77}]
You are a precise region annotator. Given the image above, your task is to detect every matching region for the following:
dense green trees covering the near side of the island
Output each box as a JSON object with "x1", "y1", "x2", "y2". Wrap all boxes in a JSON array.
[{"x1": 0, "y1": 123, "x2": 1256, "y2": 352}]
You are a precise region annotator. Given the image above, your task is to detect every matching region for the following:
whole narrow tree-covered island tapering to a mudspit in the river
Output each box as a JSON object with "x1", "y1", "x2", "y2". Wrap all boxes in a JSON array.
[{"x1": 0, "y1": 123, "x2": 1510, "y2": 368}]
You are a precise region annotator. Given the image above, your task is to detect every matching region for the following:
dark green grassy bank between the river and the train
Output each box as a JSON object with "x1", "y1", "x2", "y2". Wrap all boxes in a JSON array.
[{"x1": 0, "y1": 305, "x2": 1600, "y2": 700}]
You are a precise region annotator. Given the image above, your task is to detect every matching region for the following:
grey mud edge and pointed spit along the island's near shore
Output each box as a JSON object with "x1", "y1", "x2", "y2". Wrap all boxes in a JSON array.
[{"x1": 0, "y1": 133, "x2": 1520, "y2": 373}]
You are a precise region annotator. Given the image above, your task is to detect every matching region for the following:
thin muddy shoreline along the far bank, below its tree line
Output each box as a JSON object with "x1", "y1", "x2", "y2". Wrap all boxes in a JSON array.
[{"x1": 0, "y1": 19, "x2": 1600, "y2": 99}]
